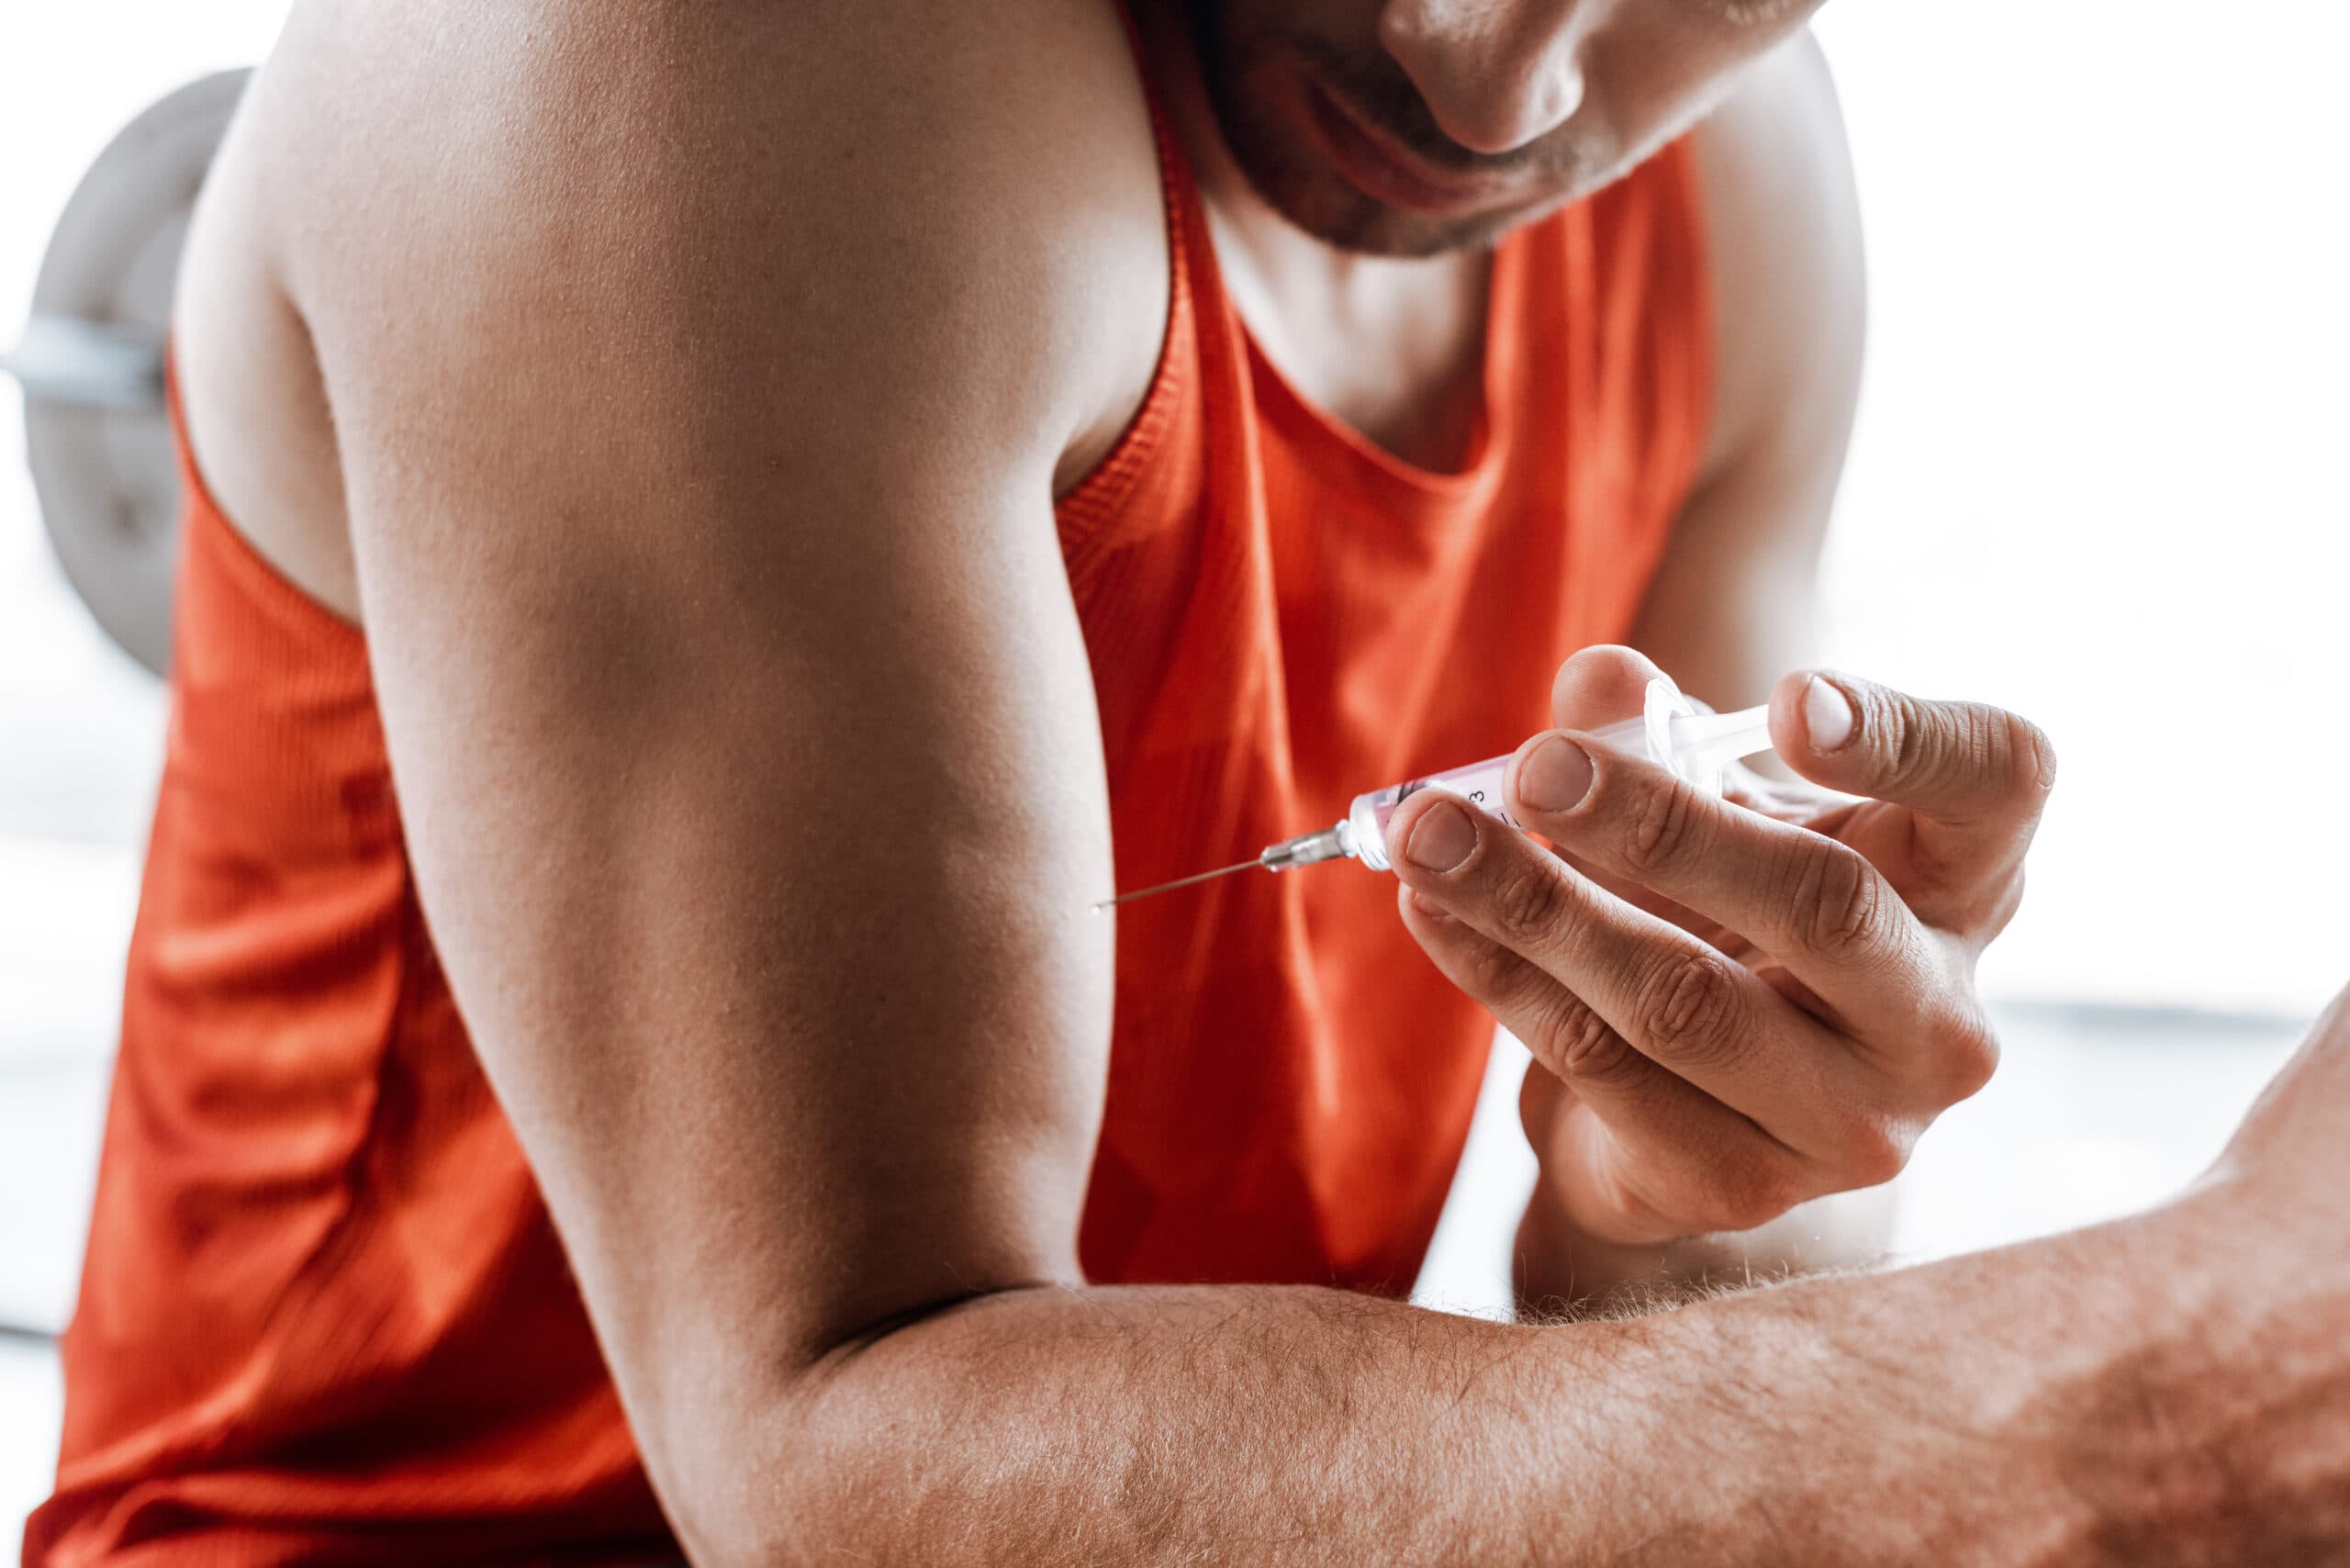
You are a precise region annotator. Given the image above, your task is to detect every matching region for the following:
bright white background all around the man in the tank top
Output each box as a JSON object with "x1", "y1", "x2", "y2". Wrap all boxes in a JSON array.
[{"x1": 0, "y1": 0, "x2": 2350, "y2": 1547}]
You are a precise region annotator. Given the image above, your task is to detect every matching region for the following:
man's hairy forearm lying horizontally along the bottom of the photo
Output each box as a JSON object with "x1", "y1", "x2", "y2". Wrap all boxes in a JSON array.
[{"x1": 728, "y1": 1193, "x2": 2350, "y2": 1568}]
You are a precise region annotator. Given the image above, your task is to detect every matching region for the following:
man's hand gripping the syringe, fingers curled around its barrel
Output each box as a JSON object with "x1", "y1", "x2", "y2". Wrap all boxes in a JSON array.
[{"x1": 1100, "y1": 649, "x2": 2052, "y2": 1288}]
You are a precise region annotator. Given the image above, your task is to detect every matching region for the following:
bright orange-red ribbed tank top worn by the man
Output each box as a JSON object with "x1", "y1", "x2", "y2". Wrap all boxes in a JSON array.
[{"x1": 26, "y1": 33, "x2": 1711, "y2": 1568}]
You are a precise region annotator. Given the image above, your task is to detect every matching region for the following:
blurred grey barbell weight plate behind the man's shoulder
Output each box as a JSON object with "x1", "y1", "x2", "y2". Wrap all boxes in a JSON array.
[{"x1": 24, "y1": 71, "x2": 252, "y2": 675}]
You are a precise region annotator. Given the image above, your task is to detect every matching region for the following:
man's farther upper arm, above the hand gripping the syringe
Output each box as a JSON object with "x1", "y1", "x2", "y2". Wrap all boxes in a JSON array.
[{"x1": 1633, "y1": 33, "x2": 1866, "y2": 708}]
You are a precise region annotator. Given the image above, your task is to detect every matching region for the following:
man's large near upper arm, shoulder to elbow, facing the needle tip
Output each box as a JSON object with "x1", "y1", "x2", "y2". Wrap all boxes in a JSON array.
[{"x1": 297, "y1": 0, "x2": 1163, "y2": 1538}]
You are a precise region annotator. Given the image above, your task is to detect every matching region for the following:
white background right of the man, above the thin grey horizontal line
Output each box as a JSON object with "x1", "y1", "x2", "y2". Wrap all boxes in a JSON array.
[{"x1": 1818, "y1": 0, "x2": 2350, "y2": 1009}]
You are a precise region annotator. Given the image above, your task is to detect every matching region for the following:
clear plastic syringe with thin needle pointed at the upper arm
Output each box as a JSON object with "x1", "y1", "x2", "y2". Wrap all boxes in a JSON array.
[{"x1": 1092, "y1": 679, "x2": 1770, "y2": 913}]
